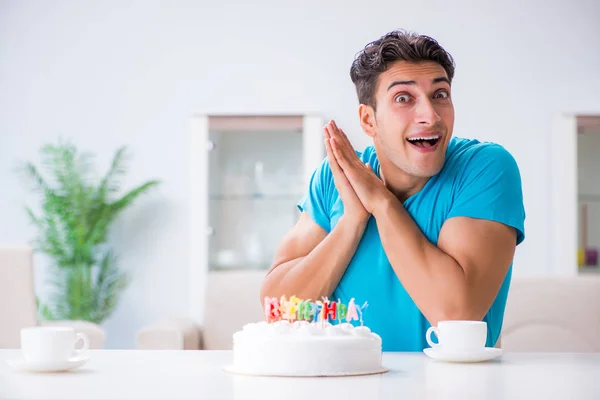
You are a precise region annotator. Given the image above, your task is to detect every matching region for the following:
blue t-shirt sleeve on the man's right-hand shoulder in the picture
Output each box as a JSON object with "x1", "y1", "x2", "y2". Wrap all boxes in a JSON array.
[{"x1": 448, "y1": 143, "x2": 525, "y2": 244}]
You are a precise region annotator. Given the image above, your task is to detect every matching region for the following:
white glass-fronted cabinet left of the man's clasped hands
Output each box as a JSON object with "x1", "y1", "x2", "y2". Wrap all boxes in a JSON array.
[{"x1": 189, "y1": 115, "x2": 325, "y2": 322}]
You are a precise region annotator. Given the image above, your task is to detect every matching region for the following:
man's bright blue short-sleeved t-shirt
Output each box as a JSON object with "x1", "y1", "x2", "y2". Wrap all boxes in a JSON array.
[{"x1": 298, "y1": 137, "x2": 525, "y2": 351}]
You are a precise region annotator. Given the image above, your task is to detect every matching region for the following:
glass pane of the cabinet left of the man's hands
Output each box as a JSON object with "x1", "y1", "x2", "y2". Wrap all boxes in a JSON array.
[{"x1": 208, "y1": 120, "x2": 305, "y2": 271}]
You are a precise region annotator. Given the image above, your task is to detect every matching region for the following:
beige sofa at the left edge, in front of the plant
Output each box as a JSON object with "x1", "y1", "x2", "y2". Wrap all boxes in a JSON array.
[{"x1": 0, "y1": 247, "x2": 105, "y2": 349}]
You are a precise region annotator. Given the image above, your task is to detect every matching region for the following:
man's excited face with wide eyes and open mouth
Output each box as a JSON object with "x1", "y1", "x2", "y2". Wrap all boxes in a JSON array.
[{"x1": 371, "y1": 61, "x2": 454, "y2": 178}]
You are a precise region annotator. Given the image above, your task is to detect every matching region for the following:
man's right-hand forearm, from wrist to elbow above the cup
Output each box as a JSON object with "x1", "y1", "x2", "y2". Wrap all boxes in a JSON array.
[{"x1": 374, "y1": 195, "x2": 472, "y2": 325}]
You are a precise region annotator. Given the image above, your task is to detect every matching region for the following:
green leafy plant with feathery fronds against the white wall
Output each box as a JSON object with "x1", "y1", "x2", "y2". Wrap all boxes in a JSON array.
[{"x1": 22, "y1": 142, "x2": 159, "y2": 324}]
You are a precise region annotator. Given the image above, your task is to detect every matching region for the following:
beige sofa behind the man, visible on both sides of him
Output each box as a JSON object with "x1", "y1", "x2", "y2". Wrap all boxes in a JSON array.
[{"x1": 137, "y1": 271, "x2": 600, "y2": 352}]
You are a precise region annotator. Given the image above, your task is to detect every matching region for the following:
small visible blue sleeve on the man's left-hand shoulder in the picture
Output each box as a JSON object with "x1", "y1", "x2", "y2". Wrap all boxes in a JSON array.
[{"x1": 298, "y1": 158, "x2": 334, "y2": 232}]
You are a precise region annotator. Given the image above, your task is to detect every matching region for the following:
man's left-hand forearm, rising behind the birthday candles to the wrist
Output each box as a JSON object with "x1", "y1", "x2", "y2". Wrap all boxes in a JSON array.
[{"x1": 261, "y1": 217, "x2": 366, "y2": 300}]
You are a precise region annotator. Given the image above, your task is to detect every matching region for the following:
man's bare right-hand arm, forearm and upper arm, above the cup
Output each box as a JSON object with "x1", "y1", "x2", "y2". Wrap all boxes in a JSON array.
[{"x1": 374, "y1": 196, "x2": 516, "y2": 326}]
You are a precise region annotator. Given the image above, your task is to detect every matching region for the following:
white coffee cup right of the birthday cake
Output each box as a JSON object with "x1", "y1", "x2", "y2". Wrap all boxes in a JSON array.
[{"x1": 425, "y1": 321, "x2": 487, "y2": 352}]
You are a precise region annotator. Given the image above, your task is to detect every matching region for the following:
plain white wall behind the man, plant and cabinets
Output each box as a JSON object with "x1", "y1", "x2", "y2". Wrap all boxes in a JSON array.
[{"x1": 0, "y1": 0, "x2": 600, "y2": 347}]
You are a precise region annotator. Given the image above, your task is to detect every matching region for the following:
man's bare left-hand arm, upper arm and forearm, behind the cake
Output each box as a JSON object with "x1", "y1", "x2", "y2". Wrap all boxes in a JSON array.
[{"x1": 260, "y1": 213, "x2": 365, "y2": 300}]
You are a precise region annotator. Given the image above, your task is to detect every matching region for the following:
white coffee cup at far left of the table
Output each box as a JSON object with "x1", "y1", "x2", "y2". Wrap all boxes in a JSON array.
[{"x1": 21, "y1": 326, "x2": 89, "y2": 363}]
